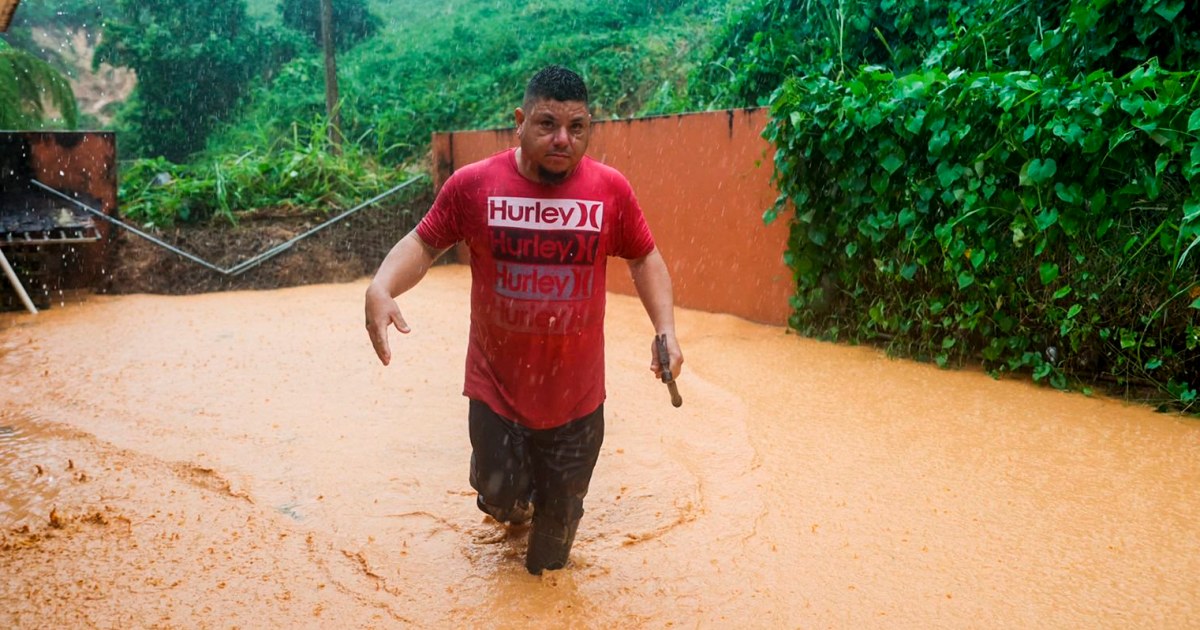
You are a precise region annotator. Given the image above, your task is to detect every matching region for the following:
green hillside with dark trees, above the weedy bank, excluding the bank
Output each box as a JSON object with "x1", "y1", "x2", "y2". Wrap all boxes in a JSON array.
[{"x1": 4, "y1": 0, "x2": 748, "y2": 164}]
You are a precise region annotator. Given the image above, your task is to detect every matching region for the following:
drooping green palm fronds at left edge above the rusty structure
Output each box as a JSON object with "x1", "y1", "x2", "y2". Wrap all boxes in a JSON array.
[{"x1": 0, "y1": 41, "x2": 79, "y2": 130}]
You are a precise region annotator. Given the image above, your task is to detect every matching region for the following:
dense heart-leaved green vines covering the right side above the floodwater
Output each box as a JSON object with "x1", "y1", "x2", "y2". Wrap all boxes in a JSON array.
[{"x1": 748, "y1": 0, "x2": 1200, "y2": 407}]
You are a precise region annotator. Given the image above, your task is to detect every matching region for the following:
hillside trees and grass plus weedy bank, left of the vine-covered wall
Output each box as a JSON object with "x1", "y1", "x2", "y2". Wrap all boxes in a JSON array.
[{"x1": 2, "y1": 0, "x2": 745, "y2": 226}]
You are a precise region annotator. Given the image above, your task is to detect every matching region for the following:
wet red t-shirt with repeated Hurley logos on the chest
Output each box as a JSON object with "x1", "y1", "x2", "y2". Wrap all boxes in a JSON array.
[{"x1": 416, "y1": 149, "x2": 654, "y2": 428}]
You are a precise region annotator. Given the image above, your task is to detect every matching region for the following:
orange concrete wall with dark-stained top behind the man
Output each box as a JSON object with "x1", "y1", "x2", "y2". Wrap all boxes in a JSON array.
[{"x1": 433, "y1": 109, "x2": 794, "y2": 325}]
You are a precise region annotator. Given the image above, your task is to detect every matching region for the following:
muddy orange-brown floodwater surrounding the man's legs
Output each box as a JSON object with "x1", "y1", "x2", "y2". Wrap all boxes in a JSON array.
[{"x1": 0, "y1": 266, "x2": 1200, "y2": 629}]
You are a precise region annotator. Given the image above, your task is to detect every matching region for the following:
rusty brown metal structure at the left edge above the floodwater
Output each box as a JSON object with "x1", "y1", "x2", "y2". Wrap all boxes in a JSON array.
[{"x1": 0, "y1": 131, "x2": 116, "y2": 312}]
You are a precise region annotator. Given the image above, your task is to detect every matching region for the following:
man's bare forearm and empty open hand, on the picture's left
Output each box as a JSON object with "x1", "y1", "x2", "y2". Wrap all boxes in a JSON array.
[{"x1": 365, "y1": 229, "x2": 445, "y2": 365}]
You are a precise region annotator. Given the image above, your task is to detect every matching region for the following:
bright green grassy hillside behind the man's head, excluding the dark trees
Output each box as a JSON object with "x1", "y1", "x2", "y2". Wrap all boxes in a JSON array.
[{"x1": 217, "y1": 0, "x2": 737, "y2": 162}]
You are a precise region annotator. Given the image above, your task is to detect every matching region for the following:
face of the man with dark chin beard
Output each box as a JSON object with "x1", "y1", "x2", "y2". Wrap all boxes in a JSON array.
[{"x1": 516, "y1": 98, "x2": 592, "y2": 184}]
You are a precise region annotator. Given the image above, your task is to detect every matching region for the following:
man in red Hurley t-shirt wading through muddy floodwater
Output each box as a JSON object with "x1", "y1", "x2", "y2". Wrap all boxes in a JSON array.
[{"x1": 366, "y1": 66, "x2": 683, "y2": 575}]
